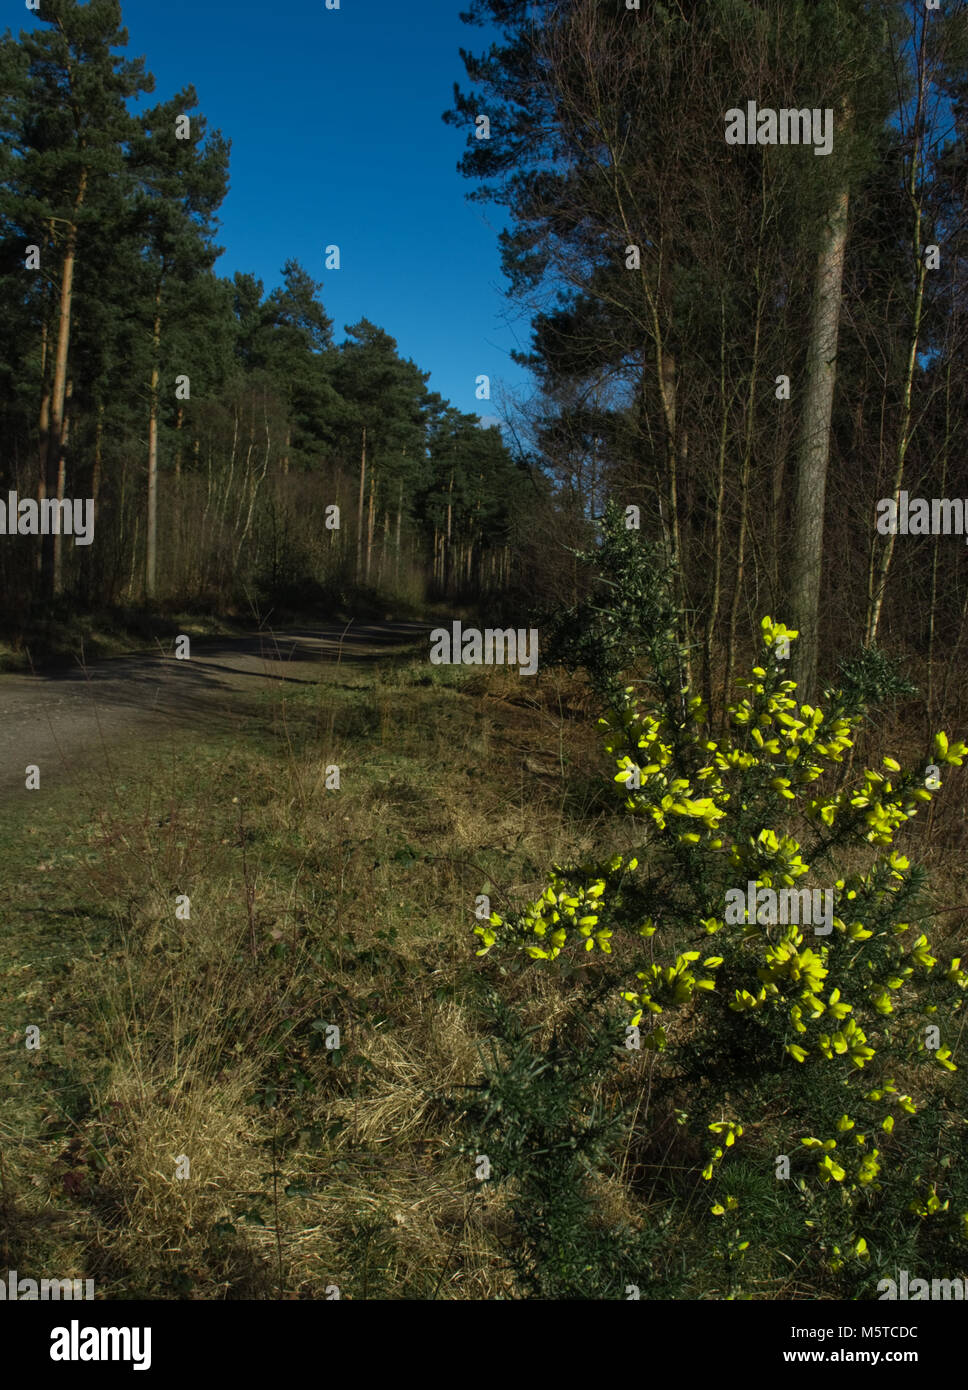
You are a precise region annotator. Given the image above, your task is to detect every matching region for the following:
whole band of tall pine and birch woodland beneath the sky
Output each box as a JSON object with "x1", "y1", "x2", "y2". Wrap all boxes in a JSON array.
[{"x1": 0, "y1": 0, "x2": 968, "y2": 703}]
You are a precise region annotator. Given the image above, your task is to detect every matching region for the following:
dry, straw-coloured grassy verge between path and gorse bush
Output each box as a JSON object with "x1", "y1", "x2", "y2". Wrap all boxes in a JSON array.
[{"x1": 0, "y1": 644, "x2": 606, "y2": 1298}]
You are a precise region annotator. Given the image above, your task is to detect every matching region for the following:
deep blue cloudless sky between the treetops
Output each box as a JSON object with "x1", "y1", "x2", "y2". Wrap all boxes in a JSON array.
[{"x1": 49, "y1": 0, "x2": 539, "y2": 416}]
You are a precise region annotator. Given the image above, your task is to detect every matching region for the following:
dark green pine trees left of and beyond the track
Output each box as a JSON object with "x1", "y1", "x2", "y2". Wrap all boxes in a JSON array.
[{"x1": 0, "y1": 0, "x2": 526, "y2": 619}]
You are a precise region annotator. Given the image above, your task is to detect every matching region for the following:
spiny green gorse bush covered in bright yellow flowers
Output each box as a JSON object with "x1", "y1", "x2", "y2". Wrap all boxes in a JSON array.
[{"x1": 476, "y1": 517, "x2": 968, "y2": 1297}]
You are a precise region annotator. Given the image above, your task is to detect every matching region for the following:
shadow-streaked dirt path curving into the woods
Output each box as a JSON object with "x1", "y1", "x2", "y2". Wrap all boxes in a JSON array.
[{"x1": 0, "y1": 621, "x2": 430, "y2": 799}]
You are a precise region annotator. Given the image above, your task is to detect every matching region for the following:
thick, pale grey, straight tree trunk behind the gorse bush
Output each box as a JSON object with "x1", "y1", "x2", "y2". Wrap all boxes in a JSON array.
[{"x1": 790, "y1": 186, "x2": 848, "y2": 701}]
